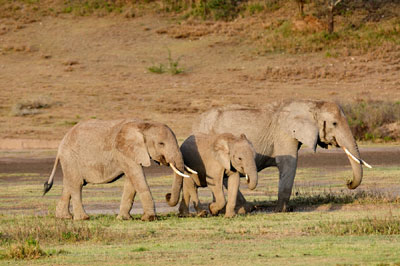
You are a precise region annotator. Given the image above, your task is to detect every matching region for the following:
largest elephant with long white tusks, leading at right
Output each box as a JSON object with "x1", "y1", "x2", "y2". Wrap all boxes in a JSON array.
[{"x1": 193, "y1": 100, "x2": 370, "y2": 211}]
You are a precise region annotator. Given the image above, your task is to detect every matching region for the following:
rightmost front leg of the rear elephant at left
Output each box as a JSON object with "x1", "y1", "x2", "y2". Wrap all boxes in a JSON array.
[{"x1": 124, "y1": 166, "x2": 156, "y2": 221}]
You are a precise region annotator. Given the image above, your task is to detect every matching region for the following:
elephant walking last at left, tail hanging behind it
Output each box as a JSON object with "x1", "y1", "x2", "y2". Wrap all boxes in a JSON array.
[{"x1": 43, "y1": 119, "x2": 189, "y2": 221}]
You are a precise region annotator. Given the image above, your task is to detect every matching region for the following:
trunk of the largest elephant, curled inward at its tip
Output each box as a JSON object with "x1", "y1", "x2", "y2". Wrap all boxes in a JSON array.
[{"x1": 336, "y1": 128, "x2": 363, "y2": 189}]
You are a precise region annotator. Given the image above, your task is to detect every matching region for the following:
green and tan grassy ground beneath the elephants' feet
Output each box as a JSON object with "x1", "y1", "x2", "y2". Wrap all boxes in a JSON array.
[{"x1": 0, "y1": 164, "x2": 400, "y2": 265}]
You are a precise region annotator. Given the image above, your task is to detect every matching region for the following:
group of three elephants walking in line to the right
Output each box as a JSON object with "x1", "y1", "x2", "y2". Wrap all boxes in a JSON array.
[{"x1": 44, "y1": 100, "x2": 371, "y2": 221}]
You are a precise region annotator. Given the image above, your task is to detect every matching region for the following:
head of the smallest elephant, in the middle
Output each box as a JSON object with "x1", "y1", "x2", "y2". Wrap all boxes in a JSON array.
[{"x1": 213, "y1": 133, "x2": 258, "y2": 190}]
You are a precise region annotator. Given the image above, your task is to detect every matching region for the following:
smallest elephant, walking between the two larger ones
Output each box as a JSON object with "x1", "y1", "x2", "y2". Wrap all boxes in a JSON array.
[{"x1": 166, "y1": 133, "x2": 258, "y2": 217}]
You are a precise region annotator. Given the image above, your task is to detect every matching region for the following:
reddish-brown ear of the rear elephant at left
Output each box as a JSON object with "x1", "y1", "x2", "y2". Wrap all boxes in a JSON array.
[{"x1": 116, "y1": 123, "x2": 151, "y2": 167}]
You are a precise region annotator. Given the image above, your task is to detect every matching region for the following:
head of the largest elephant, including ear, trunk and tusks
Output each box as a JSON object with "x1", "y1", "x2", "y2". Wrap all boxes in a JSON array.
[{"x1": 281, "y1": 102, "x2": 370, "y2": 189}]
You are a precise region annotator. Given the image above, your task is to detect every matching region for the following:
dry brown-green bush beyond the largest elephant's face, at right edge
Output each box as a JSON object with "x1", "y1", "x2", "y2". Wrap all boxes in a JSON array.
[{"x1": 341, "y1": 100, "x2": 400, "y2": 141}]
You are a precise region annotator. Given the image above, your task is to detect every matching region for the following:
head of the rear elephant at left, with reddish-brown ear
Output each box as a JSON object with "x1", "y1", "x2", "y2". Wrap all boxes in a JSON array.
[{"x1": 117, "y1": 122, "x2": 184, "y2": 175}]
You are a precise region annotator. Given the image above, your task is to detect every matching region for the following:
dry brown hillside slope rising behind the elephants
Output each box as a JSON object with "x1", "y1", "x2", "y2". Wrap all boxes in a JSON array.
[{"x1": 0, "y1": 15, "x2": 400, "y2": 140}]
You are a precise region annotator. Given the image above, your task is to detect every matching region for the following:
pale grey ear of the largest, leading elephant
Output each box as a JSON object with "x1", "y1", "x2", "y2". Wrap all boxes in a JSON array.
[{"x1": 285, "y1": 116, "x2": 319, "y2": 152}]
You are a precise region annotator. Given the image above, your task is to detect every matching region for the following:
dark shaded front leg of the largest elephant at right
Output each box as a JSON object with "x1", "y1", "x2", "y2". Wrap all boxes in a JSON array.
[{"x1": 276, "y1": 155, "x2": 297, "y2": 212}]
